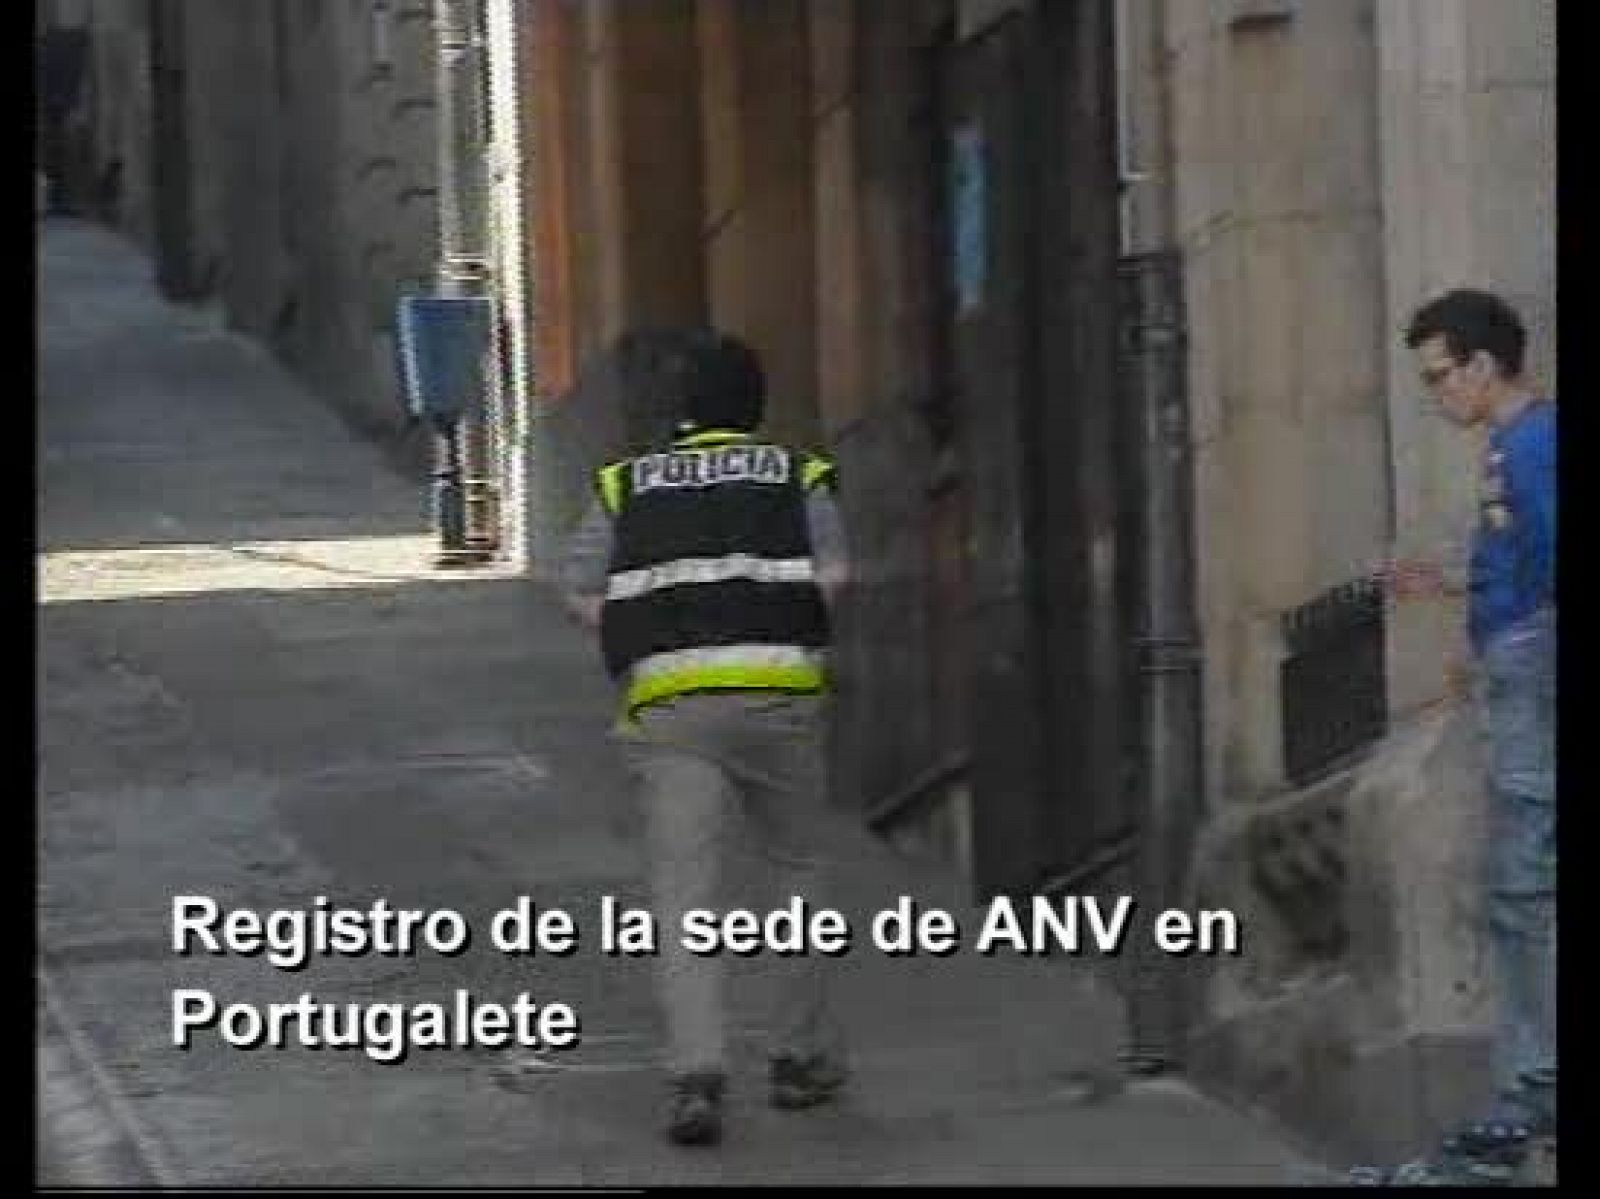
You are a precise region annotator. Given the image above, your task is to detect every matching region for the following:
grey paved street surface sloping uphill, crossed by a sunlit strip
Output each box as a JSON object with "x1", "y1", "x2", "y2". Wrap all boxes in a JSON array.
[{"x1": 38, "y1": 219, "x2": 1324, "y2": 1186}]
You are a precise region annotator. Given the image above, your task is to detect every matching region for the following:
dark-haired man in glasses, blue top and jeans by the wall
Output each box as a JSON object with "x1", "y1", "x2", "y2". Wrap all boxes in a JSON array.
[{"x1": 1397, "y1": 290, "x2": 1555, "y2": 1164}]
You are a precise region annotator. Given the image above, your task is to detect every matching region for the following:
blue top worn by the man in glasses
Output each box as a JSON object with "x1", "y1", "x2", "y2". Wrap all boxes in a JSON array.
[{"x1": 1467, "y1": 400, "x2": 1555, "y2": 647}]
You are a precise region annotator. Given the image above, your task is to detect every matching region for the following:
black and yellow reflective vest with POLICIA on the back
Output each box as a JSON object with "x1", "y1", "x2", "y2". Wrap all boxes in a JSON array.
[{"x1": 597, "y1": 431, "x2": 834, "y2": 716}]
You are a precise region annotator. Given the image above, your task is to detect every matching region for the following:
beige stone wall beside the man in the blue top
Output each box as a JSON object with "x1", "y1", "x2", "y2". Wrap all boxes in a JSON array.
[{"x1": 1157, "y1": 0, "x2": 1555, "y2": 1157}]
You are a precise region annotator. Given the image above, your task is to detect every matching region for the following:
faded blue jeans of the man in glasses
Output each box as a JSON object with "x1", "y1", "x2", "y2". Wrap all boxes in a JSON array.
[{"x1": 1480, "y1": 608, "x2": 1555, "y2": 1121}]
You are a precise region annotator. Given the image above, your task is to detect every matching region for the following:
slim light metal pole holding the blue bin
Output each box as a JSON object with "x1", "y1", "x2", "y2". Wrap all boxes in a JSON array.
[{"x1": 434, "y1": 0, "x2": 498, "y2": 562}]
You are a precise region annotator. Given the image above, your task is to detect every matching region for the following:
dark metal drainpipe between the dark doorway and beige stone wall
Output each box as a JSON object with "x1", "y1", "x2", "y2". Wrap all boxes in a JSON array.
[{"x1": 1115, "y1": 0, "x2": 1203, "y2": 1074}]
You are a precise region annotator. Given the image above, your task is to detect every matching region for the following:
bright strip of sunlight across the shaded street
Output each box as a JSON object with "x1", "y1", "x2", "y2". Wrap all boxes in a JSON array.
[{"x1": 38, "y1": 535, "x2": 522, "y2": 604}]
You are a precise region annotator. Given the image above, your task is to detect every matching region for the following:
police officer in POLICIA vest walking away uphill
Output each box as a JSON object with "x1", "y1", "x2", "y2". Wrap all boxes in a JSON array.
[{"x1": 562, "y1": 330, "x2": 846, "y2": 1145}]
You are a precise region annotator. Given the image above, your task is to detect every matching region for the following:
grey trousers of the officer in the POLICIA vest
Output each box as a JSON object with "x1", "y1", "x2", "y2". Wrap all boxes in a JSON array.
[{"x1": 616, "y1": 692, "x2": 842, "y2": 1073}]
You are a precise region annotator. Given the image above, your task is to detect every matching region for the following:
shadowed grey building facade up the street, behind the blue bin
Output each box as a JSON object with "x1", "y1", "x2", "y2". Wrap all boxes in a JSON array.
[{"x1": 58, "y1": 0, "x2": 438, "y2": 458}]
